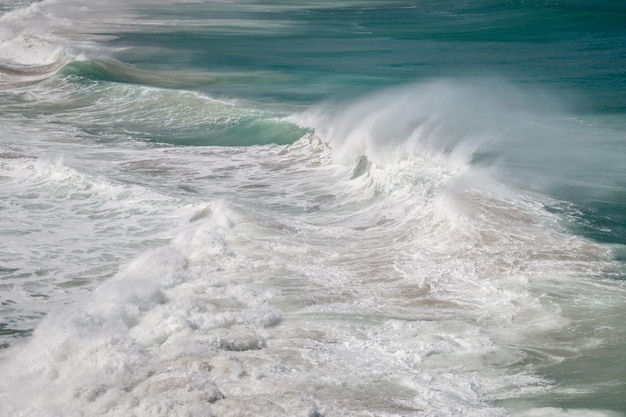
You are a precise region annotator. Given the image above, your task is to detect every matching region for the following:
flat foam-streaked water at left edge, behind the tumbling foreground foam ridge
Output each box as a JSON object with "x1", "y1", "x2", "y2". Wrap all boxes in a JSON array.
[{"x1": 0, "y1": 154, "x2": 199, "y2": 336}]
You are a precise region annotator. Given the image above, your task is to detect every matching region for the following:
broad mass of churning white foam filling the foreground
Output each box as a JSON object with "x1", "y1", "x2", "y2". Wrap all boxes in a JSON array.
[{"x1": 0, "y1": 79, "x2": 626, "y2": 416}]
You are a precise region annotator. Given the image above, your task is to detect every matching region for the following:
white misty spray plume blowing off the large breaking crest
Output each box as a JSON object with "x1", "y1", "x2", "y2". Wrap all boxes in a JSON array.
[{"x1": 293, "y1": 80, "x2": 527, "y2": 163}]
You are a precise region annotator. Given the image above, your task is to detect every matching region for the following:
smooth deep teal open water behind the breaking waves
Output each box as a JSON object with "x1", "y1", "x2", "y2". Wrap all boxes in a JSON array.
[{"x1": 102, "y1": 1, "x2": 626, "y2": 107}]
